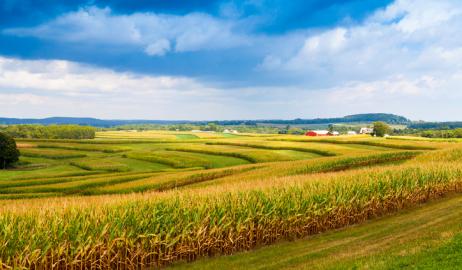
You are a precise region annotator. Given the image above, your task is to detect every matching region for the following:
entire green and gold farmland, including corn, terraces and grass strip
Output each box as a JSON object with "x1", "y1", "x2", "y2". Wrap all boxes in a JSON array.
[{"x1": 0, "y1": 131, "x2": 462, "y2": 269}]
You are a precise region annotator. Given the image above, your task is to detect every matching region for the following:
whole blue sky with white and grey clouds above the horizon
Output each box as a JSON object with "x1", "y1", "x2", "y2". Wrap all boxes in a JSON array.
[{"x1": 0, "y1": 0, "x2": 462, "y2": 121}]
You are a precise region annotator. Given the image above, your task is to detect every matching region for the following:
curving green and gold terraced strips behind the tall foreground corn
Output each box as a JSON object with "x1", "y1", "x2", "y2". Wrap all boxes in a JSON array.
[{"x1": 0, "y1": 131, "x2": 436, "y2": 198}]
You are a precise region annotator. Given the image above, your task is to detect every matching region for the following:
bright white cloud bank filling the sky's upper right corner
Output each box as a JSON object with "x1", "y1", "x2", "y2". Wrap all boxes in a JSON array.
[{"x1": 262, "y1": 0, "x2": 462, "y2": 86}]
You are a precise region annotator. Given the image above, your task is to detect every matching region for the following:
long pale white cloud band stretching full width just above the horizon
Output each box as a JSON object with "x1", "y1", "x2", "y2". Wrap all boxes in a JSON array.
[{"x1": 0, "y1": 54, "x2": 462, "y2": 120}]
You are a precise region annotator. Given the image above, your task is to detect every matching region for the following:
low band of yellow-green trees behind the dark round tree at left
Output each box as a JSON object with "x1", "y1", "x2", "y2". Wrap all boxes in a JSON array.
[{"x1": 0, "y1": 125, "x2": 96, "y2": 139}]
